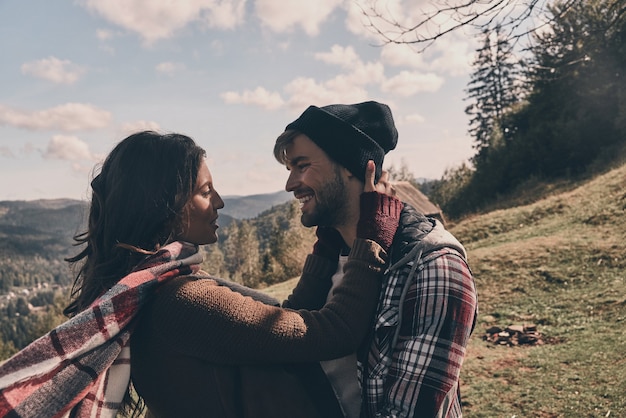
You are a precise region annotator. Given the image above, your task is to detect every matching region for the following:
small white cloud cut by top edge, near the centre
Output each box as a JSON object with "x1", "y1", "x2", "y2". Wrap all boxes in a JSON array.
[{"x1": 255, "y1": 0, "x2": 343, "y2": 36}]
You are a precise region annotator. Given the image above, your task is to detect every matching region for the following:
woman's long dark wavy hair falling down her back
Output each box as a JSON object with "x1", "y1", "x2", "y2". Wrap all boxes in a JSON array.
[{"x1": 64, "y1": 131, "x2": 206, "y2": 317}]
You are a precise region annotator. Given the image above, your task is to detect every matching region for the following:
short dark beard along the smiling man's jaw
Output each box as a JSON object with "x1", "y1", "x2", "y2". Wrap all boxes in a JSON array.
[{"x1": 300, "y1": 167, "x2": 348, "y2": 227}]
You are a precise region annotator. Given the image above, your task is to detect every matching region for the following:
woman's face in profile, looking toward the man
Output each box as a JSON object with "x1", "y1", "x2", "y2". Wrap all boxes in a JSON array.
[{"x1": 178, "y1": 160, "x2": 224, "y2": 245}]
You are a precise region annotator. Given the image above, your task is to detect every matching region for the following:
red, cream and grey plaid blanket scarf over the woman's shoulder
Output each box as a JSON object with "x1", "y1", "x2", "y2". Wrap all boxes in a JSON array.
[{"x1": 0, "y1": 242, "x2": 202, "y2": 418}]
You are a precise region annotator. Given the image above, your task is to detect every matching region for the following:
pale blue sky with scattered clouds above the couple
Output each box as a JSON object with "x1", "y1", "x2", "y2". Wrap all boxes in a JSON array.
[{"x1": 0, "y1": 0, "x2": 476, "y2": 200}]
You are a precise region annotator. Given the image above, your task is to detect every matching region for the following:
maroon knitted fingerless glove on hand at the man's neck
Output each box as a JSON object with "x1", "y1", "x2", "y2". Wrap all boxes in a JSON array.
[{"x1": 356, "y1": 192, "x2": 404, "y2": 251}]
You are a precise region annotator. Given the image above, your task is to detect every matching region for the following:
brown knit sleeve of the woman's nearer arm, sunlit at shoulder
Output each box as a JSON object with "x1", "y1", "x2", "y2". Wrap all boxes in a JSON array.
[{"x1": 140, "y1": 239, "x2": 387, "y2": 364}]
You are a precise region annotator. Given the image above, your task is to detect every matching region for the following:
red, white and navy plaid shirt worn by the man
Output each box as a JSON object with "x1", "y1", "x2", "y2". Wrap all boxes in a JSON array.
[{"x1": 359, "y1": 248, "x2": 477, "y2": 417}]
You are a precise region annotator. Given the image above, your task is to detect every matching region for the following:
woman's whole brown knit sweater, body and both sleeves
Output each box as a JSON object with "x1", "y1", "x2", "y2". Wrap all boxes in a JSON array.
[{"x1": 131, "y1": 239, "x2": 387, "y2": 418}]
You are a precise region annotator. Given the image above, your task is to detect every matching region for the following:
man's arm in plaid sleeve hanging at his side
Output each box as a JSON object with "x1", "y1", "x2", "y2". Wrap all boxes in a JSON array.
[{"x1": 379, "y1": 250, "x2": 477, "y2": 417}]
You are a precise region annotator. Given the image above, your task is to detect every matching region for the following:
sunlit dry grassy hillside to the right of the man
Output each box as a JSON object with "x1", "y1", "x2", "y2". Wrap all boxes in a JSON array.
[{"x1": 267, "y1": 166, "x2": 626, "y2": 418}]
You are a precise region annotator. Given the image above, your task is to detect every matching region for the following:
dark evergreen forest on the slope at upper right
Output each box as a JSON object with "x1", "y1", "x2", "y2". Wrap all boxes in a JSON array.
[{"x1": 427, "y1": 0, "x2": 626, "y2": 219}]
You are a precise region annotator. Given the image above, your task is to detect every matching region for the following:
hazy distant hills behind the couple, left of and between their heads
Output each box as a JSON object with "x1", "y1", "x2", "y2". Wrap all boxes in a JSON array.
[{"x1": 0, "y1": 192, "x2": 290, "y2": 295}]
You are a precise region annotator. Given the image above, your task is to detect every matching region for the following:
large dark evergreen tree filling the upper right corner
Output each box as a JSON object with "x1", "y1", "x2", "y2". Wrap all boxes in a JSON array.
[{"x1": 518, "y1": 0, "x2": 626, "y2": 177}]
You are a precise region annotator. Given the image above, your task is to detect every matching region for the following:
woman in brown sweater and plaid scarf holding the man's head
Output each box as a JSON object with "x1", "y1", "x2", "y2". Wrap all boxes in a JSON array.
[{"x1": 0, "y1": 132, "x2": 401, "y2": 417}]
